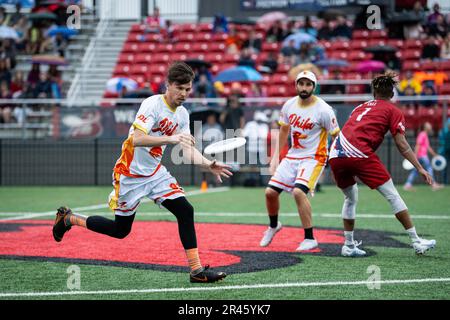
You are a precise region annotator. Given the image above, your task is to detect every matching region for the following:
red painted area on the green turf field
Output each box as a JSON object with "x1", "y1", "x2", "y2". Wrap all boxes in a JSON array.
[{"x1": 0, "y1": 220, "x2": 343, "y2": 267}]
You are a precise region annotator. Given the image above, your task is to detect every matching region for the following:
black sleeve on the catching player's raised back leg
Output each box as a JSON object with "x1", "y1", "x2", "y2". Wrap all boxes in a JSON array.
[{"x1": 86, "y1": 214, "x2": 135, "y2": 239}]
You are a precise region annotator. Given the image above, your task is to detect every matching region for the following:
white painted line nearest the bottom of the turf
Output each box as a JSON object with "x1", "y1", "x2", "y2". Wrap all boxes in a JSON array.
[{"x1": 0, "y1": 278, "x2": 450, "y2": 298}]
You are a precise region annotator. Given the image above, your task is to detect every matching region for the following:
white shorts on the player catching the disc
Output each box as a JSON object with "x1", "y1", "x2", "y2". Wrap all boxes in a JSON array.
[{"x1": 109, "y1": 166, "x2": 184, "y2": 216}]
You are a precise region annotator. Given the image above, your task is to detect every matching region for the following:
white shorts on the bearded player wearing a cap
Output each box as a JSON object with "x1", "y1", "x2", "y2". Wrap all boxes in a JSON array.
[{"x1": 269, "y1": 157, "x2": 325, "y2": 192}]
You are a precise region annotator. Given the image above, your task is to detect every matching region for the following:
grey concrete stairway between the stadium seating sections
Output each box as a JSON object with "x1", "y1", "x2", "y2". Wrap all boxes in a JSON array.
[{"x1": 68, "y1": 21, "x2": 135, "y2": 101}]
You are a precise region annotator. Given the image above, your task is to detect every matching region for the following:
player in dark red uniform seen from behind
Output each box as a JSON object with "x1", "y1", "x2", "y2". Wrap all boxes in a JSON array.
[{"x1": 329, "y1": 73, "x2": 436, "y2": 257}]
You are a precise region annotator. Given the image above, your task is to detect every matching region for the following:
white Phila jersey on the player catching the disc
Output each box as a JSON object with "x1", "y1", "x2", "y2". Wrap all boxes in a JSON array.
[{"x1": 114, "y1": 95, "x2": 190, "y2": 178}]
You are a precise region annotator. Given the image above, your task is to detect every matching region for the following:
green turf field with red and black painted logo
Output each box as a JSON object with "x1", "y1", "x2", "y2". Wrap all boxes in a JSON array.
[{"x1": 0, "y1": 186, "x2": 450, "y2": 300}]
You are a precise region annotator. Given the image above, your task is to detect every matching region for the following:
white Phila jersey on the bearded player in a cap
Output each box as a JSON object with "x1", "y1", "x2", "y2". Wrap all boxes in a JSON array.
[{"x1": 279, "y1": 96, "x2": 340, "y2": 162}]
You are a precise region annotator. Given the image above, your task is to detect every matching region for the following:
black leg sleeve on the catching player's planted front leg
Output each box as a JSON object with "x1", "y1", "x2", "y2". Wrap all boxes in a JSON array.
[{"x1": 162, "y1": 197, "x2": 197, "y2": 250}]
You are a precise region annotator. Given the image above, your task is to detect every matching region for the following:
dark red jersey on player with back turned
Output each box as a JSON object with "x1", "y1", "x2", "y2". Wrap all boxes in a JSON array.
[{"x1": 330, "y1": 100, "x2": 405, "y2": 158}]
